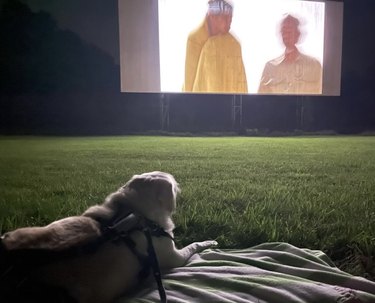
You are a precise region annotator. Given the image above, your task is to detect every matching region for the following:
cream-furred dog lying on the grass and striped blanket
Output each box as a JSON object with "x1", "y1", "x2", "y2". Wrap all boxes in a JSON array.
[{"x1": 1, "y1": 171, "x2": 217, "y2": 303}]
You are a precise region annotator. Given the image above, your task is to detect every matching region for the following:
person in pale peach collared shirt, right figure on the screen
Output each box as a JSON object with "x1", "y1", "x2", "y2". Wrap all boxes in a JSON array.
[{"x1": 258, "y1": 15, "x2": 322, "y2": 94}]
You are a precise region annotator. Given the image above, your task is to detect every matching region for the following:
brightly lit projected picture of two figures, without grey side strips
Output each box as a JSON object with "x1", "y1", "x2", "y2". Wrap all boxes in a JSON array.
[{"x1": 158, "y1": 0, "x2": 325, "y2": 94}]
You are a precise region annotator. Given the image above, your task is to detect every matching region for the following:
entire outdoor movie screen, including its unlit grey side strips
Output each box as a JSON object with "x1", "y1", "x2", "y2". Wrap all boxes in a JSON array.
[{"x1": 119, "y1": 0, "x2": 343, "y2": 96}]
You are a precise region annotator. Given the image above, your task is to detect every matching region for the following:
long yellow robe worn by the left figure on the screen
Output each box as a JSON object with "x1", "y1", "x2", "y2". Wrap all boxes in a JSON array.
[{"x1": 184, "y1": 22, "x2": 247, "y2": 93}]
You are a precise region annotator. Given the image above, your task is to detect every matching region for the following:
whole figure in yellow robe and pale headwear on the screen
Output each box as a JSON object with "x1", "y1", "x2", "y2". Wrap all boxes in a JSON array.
[{"x1": 183, "y1": 0, "x2": 247, "y2": 93}]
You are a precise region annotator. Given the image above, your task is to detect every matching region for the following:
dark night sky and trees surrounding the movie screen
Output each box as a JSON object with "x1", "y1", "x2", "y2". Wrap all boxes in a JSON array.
[{"x1": 0, "y1": 0, "x2": 375, "y2": 135}]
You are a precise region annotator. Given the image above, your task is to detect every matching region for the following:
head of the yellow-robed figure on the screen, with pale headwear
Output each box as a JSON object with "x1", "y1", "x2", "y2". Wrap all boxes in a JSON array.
[{"x1": 207, "y1": 0, "x2": 233, "y2": 36}]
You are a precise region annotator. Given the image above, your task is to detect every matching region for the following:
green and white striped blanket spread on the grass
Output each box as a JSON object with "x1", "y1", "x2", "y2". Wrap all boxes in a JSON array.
[{"x1": 117, "y1": 243, "x2": 375, "y2": 303}]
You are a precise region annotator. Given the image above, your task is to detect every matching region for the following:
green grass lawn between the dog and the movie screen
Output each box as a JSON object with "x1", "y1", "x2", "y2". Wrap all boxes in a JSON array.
[{"x1": 0, "y1": 136, "x2": 375, "y2": 278}]
